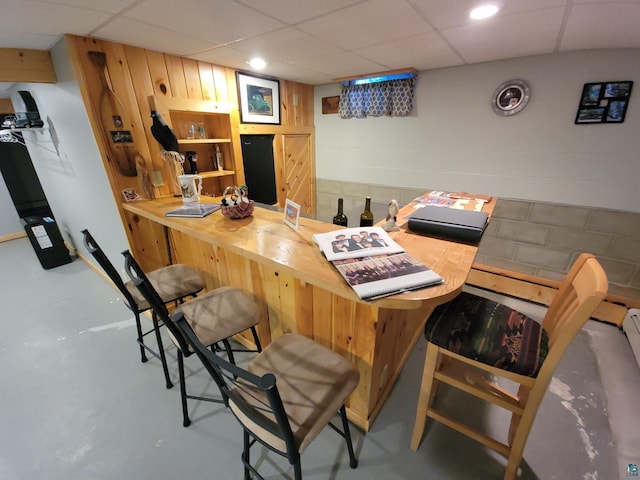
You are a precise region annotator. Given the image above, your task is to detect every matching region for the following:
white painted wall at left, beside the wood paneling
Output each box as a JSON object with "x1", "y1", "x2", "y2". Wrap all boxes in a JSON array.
[{"x1": 0, "y1": 40, "x2": 129, "y2": 266}]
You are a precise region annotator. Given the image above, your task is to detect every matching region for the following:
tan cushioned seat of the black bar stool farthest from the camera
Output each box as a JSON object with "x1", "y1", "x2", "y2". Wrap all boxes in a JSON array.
[{"x1": 125, "y1": 264, "x2": 204, "y2": 312}]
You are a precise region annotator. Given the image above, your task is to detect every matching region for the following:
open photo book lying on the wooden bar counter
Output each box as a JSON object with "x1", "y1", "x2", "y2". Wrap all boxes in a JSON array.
[{"x1": 313, "y1": 227, "x2": 443, "y2": 300}]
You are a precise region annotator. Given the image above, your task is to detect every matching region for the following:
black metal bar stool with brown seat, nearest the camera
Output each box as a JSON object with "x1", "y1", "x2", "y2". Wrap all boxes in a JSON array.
[{"x1": 167, "y1": 314, "x2": 360, "y2": 480}]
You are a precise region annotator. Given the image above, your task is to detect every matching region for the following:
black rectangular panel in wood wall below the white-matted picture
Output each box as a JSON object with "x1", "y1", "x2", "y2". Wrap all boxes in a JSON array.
[{"x1": 240, "y1": 135, "x2": 278, "y2": 205}]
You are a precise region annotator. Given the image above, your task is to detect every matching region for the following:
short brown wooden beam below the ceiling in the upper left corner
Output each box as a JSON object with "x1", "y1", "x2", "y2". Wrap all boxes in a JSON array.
[{"x1": 0, "y1": 48, "x2": 56, "y2": 83}]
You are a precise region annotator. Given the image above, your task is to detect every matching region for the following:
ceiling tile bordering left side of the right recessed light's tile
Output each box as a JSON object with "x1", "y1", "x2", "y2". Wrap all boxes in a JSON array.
[{"x1": 298, "y1": 0, "x2": 432, "y2": 49}]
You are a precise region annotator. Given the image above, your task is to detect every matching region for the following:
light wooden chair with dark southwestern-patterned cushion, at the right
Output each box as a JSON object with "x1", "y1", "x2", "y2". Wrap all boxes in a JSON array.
[{"x1": 411, "y1": 254, "x2": 607, "y2": 480}]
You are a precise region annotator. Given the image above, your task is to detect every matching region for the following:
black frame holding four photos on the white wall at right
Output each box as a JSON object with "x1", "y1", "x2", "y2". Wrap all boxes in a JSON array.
[{"x1": 575, "y1": 81, "x2": 633, "y2": 123}]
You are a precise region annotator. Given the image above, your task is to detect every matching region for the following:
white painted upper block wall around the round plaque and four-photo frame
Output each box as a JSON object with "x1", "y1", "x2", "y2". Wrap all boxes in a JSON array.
[{"x1": 315, "y1": 49, "x2": 640, "y2": 212}]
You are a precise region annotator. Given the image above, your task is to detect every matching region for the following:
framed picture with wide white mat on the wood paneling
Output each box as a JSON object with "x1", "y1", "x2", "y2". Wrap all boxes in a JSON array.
[{"x1": 236, "y1": 72, "x2": 280, "y2": 125}]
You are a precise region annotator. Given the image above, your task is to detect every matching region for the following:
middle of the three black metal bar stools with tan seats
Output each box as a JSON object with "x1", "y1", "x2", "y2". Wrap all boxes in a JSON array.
[{"x1": 122, "y1": 250, "x2": 262, "y2": 427}]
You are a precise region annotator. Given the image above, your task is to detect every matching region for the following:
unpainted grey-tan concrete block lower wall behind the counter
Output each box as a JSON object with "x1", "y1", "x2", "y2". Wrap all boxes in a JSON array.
[{"x1": 316, "y1": 179, "x2": 640, "y2": 299}]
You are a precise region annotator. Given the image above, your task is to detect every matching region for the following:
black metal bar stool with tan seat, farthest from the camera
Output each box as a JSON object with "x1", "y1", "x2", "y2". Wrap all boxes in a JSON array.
[{"x1": 82, "y1": 229, "x2": 204, "y2": 388}]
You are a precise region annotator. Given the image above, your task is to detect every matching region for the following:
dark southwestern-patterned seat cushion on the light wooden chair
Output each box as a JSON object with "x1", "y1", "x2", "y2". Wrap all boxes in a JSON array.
[{"x1": 425, "y1": 292, "x2": 549, "y2": 377}]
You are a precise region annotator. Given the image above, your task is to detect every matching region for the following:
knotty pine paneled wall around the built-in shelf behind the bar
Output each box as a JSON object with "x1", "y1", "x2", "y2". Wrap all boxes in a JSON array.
[{"x1": 66, "y1": 35, "x2": 315, "y2": 251}]
